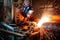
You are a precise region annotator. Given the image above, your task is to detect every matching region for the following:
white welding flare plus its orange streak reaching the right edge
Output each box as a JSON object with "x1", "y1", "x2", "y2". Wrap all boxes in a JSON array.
[{"x1": 37, "y1": 15, "x2": 60, "y2": 28}]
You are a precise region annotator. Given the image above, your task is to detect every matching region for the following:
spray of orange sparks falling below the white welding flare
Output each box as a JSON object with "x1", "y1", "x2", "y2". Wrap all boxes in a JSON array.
[{"x1": 40, "y1": 27, "x2": 56, "y2": 40}]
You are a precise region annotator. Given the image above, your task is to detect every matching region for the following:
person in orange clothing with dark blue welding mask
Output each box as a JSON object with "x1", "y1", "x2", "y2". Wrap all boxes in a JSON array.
[{"x1": 15, "y1": 0, "x2": 33, "y2": 26}]
